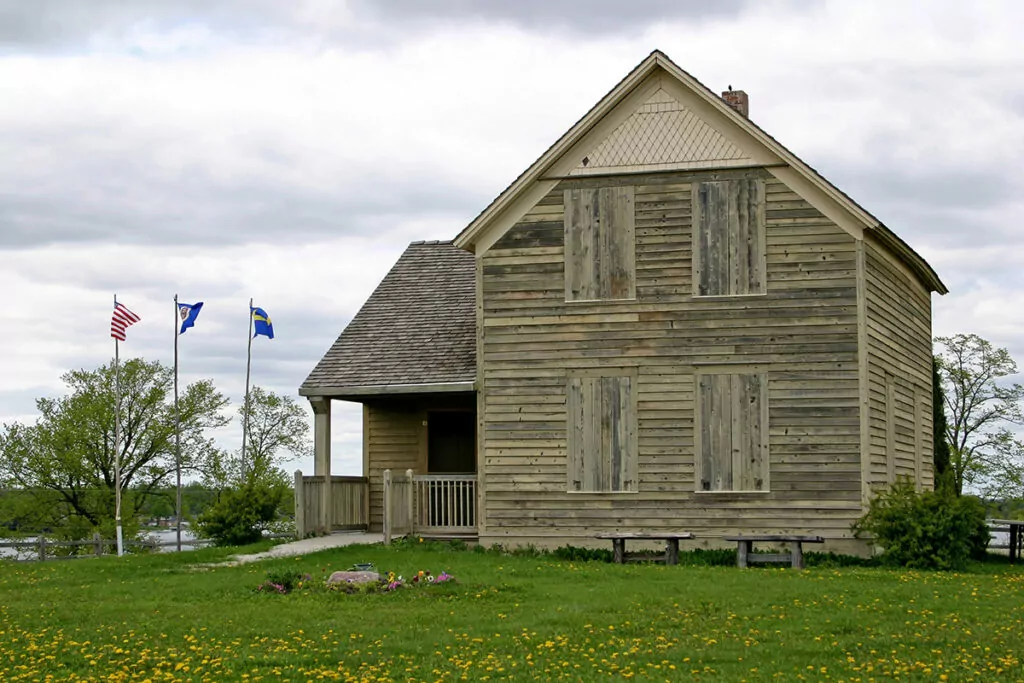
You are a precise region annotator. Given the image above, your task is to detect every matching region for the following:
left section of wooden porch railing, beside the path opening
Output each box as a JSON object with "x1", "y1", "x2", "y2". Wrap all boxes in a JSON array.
[{"x1": 295, "y1": 470, "x2": 370, "y2": 539}]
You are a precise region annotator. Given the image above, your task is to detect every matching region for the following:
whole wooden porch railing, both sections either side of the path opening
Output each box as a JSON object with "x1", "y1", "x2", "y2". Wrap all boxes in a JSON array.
[{"x1": 295, "y1": 470, "x2": 477, "y2": 543}]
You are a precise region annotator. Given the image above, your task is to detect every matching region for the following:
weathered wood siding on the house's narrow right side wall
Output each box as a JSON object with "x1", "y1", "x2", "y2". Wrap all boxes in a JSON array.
[{"x1": 863, "y1": 238, "x2": 934, "y2": 490}]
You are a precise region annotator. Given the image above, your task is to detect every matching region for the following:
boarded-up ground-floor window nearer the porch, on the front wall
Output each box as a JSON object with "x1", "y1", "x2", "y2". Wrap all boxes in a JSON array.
[{"x1": 566, "y1": 376, "x2": 637, "y2": 492}]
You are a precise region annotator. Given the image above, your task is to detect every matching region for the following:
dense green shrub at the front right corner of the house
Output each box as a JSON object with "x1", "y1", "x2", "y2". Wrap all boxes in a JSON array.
[{"x1": 854, "y1": 481, "x2": 988, "y2": 569}]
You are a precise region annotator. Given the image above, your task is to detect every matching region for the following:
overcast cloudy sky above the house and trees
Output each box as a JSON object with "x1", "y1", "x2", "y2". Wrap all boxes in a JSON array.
[{"x1": 0, "y1": 0, "x2": 1024, "y2": 481}]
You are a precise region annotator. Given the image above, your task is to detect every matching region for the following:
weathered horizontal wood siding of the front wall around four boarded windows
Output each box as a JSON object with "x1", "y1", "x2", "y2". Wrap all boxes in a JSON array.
[{"x1": 478, "y1": 169, "x2": 861, "y2": 545}]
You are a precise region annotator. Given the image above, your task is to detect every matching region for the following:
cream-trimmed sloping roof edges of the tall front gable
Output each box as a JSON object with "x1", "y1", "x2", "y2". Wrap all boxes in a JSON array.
[{"x1": 454, "y1": 50, "x2": 948, "y2": 294}]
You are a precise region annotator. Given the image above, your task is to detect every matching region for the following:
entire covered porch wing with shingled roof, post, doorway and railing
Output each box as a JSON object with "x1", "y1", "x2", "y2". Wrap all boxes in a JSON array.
[{"x1": 296, "y1": 242, "x2": 477, "y2": 533}]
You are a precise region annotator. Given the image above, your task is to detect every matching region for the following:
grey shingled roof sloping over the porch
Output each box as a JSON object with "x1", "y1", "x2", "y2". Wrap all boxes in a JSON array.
[{"x1": 299, "y1": 242, "x2": 476, "y2": 395}]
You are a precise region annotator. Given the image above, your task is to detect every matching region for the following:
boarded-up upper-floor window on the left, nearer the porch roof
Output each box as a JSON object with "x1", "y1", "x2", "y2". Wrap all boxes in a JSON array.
[{"x1": 564, "y1": 186, "x2": 636, "y2": 301}]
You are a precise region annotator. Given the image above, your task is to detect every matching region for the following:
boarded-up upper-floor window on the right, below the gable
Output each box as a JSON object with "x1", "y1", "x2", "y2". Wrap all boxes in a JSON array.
[{"x1": 693, "y1": 179, "x2": 765, "y2": 296}]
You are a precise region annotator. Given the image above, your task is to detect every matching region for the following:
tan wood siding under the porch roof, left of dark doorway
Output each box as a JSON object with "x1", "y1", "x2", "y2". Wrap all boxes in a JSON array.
[{"x1": 362, "y1": 395, "x2": 474, "y2": 531}]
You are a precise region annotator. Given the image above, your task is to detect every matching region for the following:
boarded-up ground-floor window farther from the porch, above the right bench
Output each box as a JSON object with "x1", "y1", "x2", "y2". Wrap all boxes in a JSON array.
[{"x1": 696, "y1": 374, "x2": 768, "y2": 490}]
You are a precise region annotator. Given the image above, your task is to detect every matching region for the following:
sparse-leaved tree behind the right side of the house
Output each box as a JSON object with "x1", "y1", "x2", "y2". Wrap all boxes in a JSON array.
[{"x1": 935, "y1": 334, "x2": 1024, "y2": 498}]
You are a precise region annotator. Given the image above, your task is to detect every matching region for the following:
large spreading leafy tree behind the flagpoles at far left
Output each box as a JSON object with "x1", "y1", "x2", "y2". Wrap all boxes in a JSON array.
[{"x1": 0, "y1": 358, "x2": 229, "y2": 538}]
